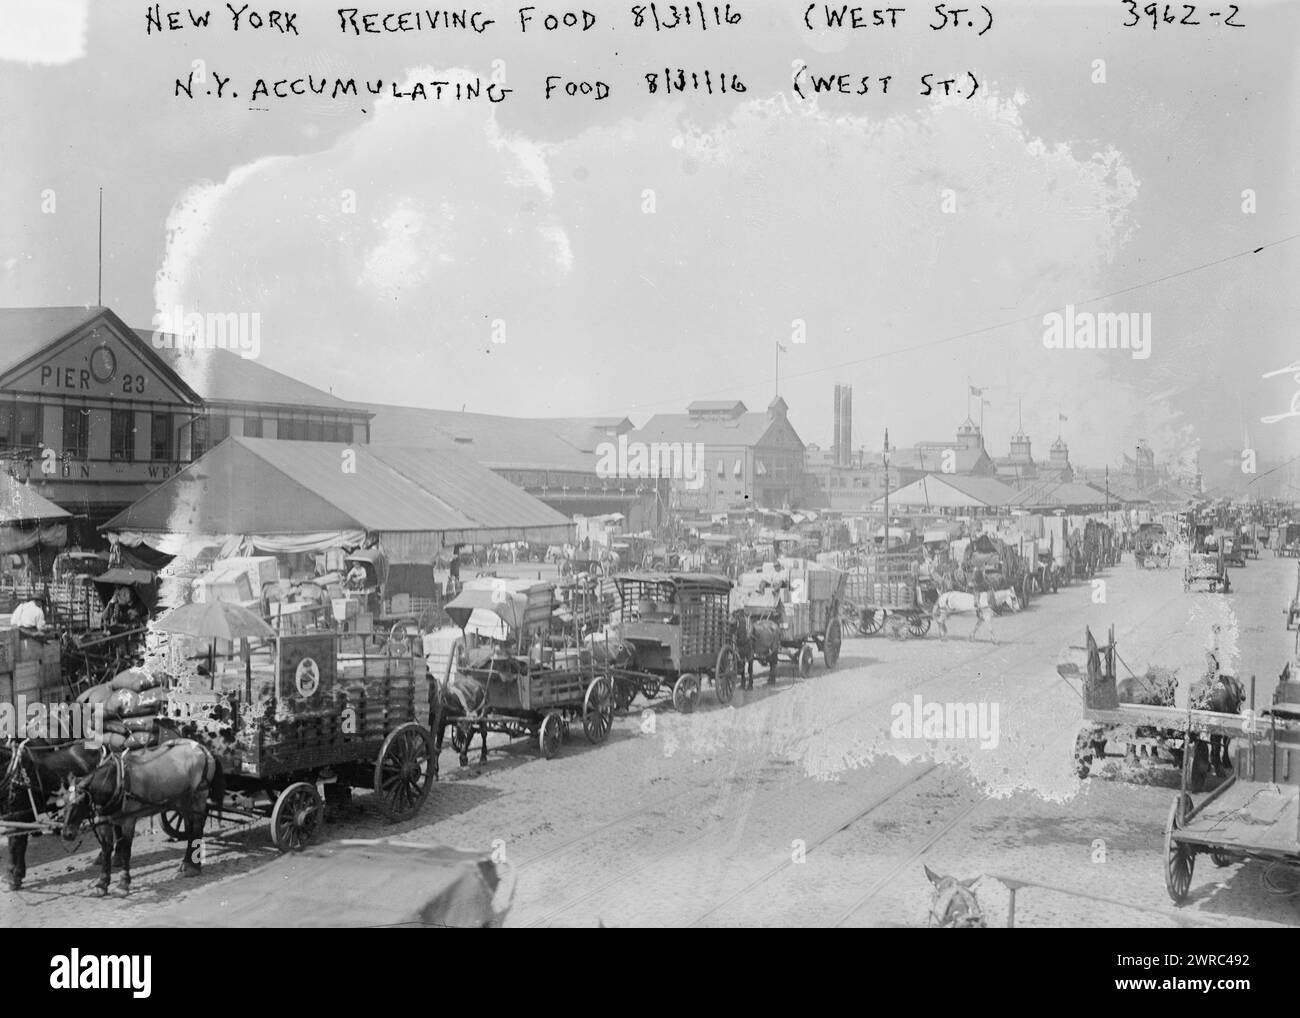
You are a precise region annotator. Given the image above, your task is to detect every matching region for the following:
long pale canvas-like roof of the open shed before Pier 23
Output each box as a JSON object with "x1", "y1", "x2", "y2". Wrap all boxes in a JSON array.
[{"x1": 104, "y1": 437, "x2": 572, "y2": 560}]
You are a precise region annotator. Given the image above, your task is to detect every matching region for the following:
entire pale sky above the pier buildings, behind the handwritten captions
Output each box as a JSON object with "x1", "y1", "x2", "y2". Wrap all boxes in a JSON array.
[{"x1": 0, "y1": 0, "x2": 1300, "y2": 465}]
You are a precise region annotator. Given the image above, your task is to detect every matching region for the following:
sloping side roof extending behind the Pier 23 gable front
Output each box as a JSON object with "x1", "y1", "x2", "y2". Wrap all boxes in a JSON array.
[{"x1": 134, "y1": 329, "x2": 364, "y2": 413}]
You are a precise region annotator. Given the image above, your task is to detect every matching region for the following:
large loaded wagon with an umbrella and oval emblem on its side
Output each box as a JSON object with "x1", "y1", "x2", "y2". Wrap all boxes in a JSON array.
[{"x1": 155, "y1": 631, "x2": 437, "y2": 852}]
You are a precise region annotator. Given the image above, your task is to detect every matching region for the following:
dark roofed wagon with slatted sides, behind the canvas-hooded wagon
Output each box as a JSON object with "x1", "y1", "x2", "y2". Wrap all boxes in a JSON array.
[{"x1": 611, "y1": 572, "x2": 740, "y2": 712}]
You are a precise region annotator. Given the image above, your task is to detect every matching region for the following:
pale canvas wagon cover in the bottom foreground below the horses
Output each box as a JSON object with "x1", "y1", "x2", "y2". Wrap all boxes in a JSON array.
[{"x1": 143, "y1": 840, "x2": 504, "y2": 928}]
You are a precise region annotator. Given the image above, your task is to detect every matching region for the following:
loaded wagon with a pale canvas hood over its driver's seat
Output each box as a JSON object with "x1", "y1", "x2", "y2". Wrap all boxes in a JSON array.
[{"x1": 434, "y1": 579, "x2": 614, "y2": 759}]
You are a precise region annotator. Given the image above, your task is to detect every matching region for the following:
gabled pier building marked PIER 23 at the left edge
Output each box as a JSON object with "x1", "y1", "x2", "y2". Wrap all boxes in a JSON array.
[{"x1": 0, "y1": 307, "x2": 371, "y2": 538}]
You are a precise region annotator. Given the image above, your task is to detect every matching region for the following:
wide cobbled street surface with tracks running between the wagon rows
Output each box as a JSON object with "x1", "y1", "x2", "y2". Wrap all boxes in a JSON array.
[{"x1": 0, "y1": 551, "x2": 1300, "y2": 927}]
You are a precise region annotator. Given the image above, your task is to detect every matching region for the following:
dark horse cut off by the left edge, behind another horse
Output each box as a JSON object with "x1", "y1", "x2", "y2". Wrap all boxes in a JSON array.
[{"x1": 0, "y1": 738, "x2": 104, "y2": 891}]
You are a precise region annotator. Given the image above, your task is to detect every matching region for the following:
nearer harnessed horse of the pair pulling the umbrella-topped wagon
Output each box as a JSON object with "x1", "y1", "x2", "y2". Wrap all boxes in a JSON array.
[{"x1": 62, "y1": 738, "x2": 225, "y2": 897}]
